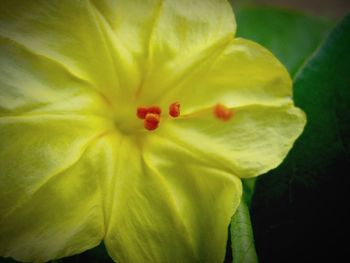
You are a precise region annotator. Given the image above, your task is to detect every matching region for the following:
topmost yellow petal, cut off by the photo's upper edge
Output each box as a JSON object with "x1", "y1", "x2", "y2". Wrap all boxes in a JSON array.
[{"x1": 93, "y1": 0, "x2": 236, "y2": 103}]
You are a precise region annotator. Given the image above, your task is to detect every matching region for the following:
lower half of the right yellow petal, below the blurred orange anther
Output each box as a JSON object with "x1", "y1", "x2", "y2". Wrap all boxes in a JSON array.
[{"x1": 158, "y1": 105, "x2": 306, "y2": 178}]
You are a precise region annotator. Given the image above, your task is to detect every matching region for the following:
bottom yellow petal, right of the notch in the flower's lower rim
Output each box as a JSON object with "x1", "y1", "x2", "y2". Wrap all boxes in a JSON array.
[{"x1": 100, "y1": 136, "x2": 242, "y2": 263}]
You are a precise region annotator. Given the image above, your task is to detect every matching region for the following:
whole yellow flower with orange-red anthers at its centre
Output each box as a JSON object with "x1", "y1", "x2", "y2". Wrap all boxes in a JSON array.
[{"x1": 0, "y1": 0, "x2": 305, "y2": 263}]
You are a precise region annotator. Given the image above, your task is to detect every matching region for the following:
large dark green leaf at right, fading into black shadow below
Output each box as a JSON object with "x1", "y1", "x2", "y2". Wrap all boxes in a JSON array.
[{"x1": 252, "y1": 15, "x2": 350, "y2": 262}]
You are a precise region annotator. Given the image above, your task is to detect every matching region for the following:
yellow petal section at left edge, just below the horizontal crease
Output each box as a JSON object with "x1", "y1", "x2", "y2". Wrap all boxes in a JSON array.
[{"x1": 0, "y1": 115, "x2": 111, "y2": 219}]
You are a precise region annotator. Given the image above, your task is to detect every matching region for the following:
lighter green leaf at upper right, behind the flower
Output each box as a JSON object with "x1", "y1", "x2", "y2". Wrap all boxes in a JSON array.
[{"x1": 236, "y1": 7, "x2": 332, "y2": 75}]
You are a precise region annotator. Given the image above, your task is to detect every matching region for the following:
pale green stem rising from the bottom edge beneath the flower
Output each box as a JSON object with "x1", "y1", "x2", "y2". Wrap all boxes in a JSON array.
[{"x1": 230, "y1": 197, "x2": 258, "y2": 263}]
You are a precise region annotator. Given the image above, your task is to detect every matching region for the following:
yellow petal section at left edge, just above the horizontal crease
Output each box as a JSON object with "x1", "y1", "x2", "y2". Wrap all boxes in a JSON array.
[{"x1": 0, "y1": 37, "x2": 109, "y2": 116}]
